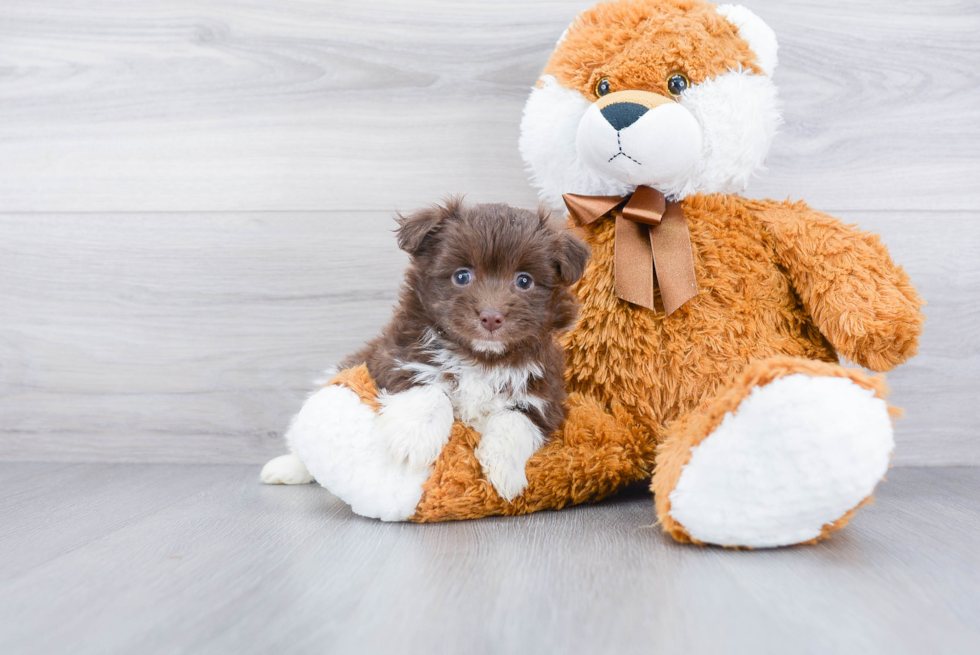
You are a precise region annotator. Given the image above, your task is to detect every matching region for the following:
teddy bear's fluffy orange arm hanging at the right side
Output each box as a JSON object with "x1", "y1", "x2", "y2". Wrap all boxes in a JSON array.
[{"x1": 759, "y1": 203, "x2": 925, "y2": 371}]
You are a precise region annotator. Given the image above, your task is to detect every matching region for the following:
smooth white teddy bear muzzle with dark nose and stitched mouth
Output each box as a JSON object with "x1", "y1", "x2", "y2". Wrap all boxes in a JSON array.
[{"x1": 575, "y1": 102, "x2": 704, "y2": 189}]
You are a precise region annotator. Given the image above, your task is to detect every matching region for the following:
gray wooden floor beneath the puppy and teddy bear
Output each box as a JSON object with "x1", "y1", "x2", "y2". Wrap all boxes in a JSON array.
[{"x1": 0, "y1": 463, "x2": 980, "y2": 655}]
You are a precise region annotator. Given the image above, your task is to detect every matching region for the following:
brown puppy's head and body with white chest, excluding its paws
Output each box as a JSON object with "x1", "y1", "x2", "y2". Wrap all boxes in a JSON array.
[{"x1": 343, "y1": 199, "x2": 589, "y2": 435}]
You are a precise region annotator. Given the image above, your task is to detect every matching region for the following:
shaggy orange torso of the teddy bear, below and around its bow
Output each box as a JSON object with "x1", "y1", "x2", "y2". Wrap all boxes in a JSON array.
[{"x1": 564, "y1": 208, "x2": 837, "y2": 438}]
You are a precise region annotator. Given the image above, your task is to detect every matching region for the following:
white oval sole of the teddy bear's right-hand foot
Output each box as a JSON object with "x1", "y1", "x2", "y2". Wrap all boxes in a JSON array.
[{"x1": 670, "y1": 374, "x2": 895, "y2": 548}]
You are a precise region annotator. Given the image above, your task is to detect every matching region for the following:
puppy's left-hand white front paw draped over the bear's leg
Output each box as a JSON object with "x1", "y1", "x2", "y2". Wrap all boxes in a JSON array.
[{"x1": 377, "y1": 386, "x2": 453, "y2": 469}]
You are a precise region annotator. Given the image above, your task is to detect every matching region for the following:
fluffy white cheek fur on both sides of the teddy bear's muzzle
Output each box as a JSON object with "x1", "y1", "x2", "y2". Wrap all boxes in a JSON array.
[{"x1": 519, "y1": 71, "x2": 781, "y2": 208}]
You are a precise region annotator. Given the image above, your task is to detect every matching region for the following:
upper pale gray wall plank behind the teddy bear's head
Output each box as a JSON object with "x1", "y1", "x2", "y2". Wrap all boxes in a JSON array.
[{"x1": 0, "y1": 0, "x2": 980, "y2": 211}]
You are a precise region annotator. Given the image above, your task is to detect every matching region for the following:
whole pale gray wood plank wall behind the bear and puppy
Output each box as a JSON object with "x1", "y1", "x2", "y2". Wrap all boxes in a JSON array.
[{"x1": 0, "y1": 0, "x2": 980, "y2": 464}]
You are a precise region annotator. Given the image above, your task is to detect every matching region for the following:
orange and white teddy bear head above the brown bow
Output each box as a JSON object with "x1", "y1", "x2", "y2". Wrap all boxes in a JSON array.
[{"x1": 520, "y1": 0, "x2": 780, "y2": 207}]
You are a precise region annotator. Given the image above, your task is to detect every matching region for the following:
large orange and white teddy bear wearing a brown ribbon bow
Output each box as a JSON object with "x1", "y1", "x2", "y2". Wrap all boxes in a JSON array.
[{"x1": 267, "y1": 0, "x2": 924, "y2": 548}]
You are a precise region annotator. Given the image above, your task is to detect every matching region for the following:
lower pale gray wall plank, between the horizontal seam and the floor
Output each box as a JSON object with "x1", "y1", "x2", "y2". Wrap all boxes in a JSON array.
[{"x1": 0, "y1": 212, "x2": 980, "y2": 465}]
